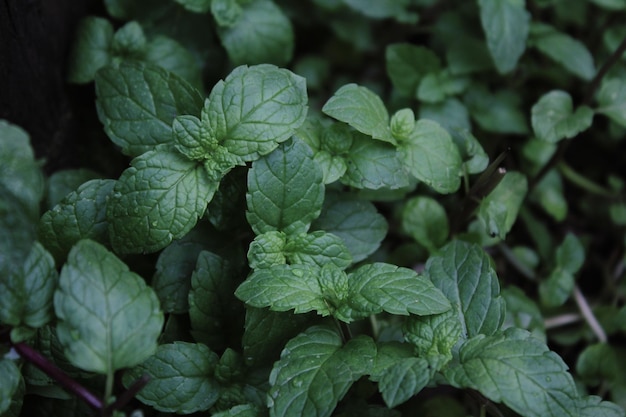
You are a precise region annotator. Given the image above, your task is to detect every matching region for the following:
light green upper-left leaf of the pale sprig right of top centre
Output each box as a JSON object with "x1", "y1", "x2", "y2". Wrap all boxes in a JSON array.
[{"x1": 322, "y1": 84, "x2": 396, "y2": 144}]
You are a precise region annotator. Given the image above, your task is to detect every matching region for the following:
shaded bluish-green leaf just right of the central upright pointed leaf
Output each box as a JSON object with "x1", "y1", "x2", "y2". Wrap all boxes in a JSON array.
[{"x1": 311, "y1": 194, "x2": 388, "y2": 262}]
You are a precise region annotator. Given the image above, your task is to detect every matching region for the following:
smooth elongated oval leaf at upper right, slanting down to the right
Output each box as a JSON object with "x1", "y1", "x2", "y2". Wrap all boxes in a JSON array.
[{"x1": 529, "y1": 23, "x2": 596, "y2": 81}]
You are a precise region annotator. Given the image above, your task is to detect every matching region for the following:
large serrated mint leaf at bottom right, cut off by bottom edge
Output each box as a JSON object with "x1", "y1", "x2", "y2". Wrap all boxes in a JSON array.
[{"x1": 444, "y1": 328, "x2": 579, "y2": 417}]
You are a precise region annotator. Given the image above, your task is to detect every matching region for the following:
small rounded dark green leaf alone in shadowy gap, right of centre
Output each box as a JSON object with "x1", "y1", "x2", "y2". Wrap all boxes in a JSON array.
[{"x1": 401, "y1": 196, "x2": 450, "y2": 253}]
